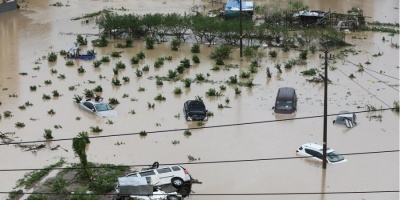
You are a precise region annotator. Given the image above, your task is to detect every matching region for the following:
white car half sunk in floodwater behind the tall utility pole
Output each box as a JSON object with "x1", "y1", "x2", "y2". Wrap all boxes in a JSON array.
[{"x1": 296, "y1": 143, "x2": 347, "y2": 164}]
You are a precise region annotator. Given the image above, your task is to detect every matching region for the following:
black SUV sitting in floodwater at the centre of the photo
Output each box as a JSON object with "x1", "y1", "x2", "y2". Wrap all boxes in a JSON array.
[{"x1": 183, "y1": 100, "x2": 208, "y2": 121}]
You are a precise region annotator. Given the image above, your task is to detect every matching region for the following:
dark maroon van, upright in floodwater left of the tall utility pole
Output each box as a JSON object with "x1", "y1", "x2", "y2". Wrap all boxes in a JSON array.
[{"x1": 273, "y1": 87, "x2": 297, "y2": 114}]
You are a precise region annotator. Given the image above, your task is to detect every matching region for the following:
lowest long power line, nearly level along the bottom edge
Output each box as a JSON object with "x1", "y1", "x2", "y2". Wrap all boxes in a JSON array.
[{"x1": 0, "y1": 190, "x2": 399, "y2": 196}]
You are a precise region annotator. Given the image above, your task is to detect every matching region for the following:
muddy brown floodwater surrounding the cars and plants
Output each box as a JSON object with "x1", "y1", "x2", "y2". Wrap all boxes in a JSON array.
[{"x1": 0, "y1": 0, "x2": 399, "y2": 200}]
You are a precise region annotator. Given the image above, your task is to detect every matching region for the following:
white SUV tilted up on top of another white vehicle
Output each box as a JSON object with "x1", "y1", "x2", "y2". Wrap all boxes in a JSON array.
[{"x1": 125, "y1": 165, "x2": 192, "y2": 197}]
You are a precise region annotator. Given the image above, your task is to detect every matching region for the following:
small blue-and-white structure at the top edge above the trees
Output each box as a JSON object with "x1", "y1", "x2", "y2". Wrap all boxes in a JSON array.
[{"x1": 224, "y1": 0, "x2": 254, "y2": 18}]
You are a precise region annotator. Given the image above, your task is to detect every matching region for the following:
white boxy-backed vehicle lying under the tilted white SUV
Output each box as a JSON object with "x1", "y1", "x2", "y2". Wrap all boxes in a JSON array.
[{"x1": 113, "y1": 177, "x2": 182, "y2": 200}]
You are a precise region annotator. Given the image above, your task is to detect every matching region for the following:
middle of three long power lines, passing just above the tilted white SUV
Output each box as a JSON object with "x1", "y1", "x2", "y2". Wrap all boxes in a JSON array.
[{"x1": 0, "y1": 150, "x2": 400, "y2": 172}]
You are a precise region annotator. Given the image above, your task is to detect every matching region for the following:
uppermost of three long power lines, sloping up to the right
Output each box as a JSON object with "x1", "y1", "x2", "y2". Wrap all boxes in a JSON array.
[{"x1": 0, "y1": 106, "x2": 393, "y2": 146}]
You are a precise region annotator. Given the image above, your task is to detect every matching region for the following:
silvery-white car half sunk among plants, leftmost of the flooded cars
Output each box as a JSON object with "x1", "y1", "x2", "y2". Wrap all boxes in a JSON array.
[{"x1": 79, "y1": 99, "x2": 118, "y2": 117}]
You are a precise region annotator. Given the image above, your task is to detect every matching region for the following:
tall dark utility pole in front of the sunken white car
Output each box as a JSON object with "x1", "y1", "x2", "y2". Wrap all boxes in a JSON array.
[{"x1": 322, "y1": 42, "x2": 328, "y2": 169}]
